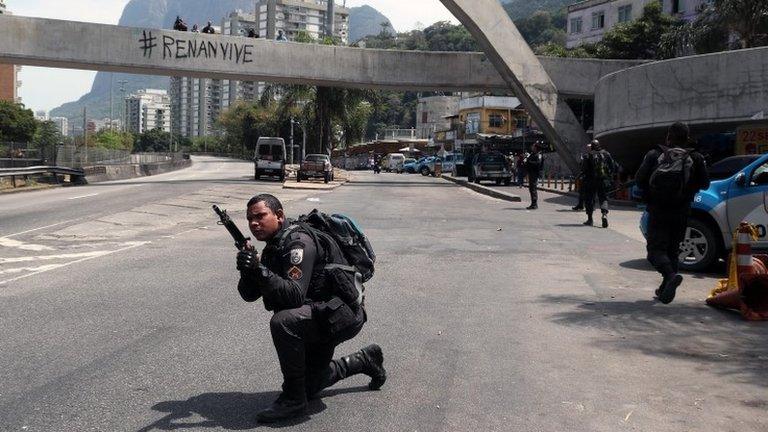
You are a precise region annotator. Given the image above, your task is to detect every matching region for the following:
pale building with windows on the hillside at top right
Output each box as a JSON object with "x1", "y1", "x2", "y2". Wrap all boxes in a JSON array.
[{"x1": 565, "y1": 0, "x2": 656, "y2": 48}]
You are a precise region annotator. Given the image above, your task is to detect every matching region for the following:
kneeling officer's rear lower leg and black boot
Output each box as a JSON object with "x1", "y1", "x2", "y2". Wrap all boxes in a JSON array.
[{"x1": 307, "y1": 344, "x2": 387, "y2": 399}]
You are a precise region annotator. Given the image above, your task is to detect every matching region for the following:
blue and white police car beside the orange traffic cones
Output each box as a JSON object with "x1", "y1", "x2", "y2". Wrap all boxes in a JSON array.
[{"x1": 640, "y1": 154, "x2": 768, "y2": 271}]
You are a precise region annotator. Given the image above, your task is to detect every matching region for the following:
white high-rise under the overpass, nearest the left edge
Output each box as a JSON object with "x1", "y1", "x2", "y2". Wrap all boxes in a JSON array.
[{"x1": 124, "y1": 89, "x2": 171, "y2": 134}]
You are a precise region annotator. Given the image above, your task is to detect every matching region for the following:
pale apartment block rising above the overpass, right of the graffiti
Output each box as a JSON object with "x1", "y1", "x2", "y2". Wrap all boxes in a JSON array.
[{"x1": 256, "y1": 0, "x2": 349, "y2": 45}]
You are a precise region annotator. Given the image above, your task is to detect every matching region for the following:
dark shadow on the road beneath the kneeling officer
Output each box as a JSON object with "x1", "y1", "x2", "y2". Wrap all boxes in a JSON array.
[{"x1": 138, "y1": 387, "x2": 368, "y2": 432}]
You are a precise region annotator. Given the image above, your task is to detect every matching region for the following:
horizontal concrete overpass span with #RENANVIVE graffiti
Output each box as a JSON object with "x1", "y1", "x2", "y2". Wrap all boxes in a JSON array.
[{"x1": 0, "y1": 15, "x2": 636, "y2": 96}]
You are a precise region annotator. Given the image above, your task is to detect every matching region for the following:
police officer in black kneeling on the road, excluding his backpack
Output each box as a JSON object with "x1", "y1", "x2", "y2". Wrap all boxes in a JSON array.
[{"x1": 237, "y1": 194, "x2": 387, "y2": 423}]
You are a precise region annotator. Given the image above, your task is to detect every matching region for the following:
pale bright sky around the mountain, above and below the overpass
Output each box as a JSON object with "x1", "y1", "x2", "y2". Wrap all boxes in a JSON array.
[{"x1": 5, "y1": 0, "x2": 456, "y2": 110}]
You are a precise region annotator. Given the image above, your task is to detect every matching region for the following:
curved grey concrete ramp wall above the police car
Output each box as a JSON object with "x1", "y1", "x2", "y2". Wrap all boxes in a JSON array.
[{"x1": 594, "y1": 47, "x2": 768, "y2": 166}]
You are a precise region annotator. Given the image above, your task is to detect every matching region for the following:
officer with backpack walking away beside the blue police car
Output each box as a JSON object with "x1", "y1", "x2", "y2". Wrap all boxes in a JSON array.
[{"x1": 635, "y1": 123, "x2": 709, "y2": 304}]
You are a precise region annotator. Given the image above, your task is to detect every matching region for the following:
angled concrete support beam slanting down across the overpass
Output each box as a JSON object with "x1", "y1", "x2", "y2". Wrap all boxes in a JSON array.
[{"x1": 440, "y1": 0, "x2": 589, "y2": 172}]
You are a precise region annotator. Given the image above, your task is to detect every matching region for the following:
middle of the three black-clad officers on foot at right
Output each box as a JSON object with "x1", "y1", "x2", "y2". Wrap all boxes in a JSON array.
[{"x1": 582, "y1": 140, "x2": 617, "y2": 228}]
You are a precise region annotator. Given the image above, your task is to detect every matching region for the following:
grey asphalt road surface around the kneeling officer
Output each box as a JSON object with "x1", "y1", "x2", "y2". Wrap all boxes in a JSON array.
[{"x1": 0, "y1": 159, "x2": 768, "y2": 432}]
